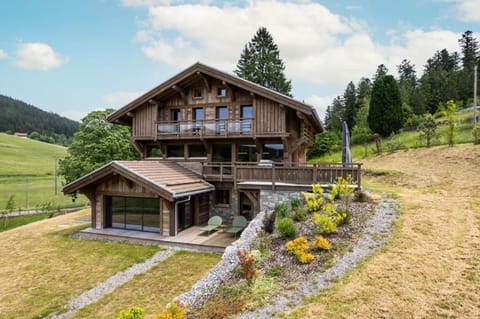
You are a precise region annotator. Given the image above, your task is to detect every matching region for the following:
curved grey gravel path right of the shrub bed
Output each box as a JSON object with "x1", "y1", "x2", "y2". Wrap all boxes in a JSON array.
[{"x1": 237, "y1": 199, "x2": 399, "y2": 319}]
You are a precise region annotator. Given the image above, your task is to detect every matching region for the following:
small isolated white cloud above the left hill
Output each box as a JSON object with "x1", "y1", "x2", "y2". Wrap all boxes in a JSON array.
[{"x1": 14, "y1": 42, "x2": 68, "y2": 71}]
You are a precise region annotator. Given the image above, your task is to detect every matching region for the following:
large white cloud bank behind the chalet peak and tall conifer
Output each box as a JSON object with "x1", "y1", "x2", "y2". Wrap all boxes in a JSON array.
[{"x1": 128, "y1": 0, "x2": 464, "y2": 90}]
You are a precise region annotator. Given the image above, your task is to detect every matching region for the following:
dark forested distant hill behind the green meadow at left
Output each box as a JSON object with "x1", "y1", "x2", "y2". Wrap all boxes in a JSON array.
[{"x1": 0, "y1": 94, "x2": 80, "y2": 138}]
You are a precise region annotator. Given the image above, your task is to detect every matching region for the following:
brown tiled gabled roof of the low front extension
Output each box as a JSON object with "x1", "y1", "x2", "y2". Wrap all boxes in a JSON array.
[{"x1": 62, "y1": 160, "x2": 214, "y2": 201}]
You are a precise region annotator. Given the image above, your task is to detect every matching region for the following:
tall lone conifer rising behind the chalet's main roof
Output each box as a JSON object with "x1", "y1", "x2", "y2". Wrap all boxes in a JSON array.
[{"x1": 235, "y1": 27, "x2": 292, "y2": 96}]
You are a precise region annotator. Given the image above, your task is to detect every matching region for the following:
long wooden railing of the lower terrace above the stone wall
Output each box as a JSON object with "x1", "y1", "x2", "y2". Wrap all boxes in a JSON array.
[{"x1": 202, "y1": 162, "x2": 362, "y2": 189}]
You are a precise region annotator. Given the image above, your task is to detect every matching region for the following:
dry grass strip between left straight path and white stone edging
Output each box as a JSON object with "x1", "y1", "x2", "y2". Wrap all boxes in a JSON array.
[{"x1": 75, "y1": 251, "x2": 220, "y2": 319}]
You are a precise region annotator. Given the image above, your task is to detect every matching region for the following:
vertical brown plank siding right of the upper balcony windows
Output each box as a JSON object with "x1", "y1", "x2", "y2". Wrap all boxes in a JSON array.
[{"x1": 253, "y1": 96, "x2": 286, "y2": 134}]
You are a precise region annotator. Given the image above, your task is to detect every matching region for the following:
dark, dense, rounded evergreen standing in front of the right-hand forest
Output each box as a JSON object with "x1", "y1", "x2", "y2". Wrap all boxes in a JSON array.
[{"x1": 368, "y1": 75, "x2": 404, "y2": 137}]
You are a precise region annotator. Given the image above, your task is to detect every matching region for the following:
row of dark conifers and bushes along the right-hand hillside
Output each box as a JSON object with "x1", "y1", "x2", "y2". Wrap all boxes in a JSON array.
[{"x1": 312, "y1": 31, "x2": 480, "y2": 155}]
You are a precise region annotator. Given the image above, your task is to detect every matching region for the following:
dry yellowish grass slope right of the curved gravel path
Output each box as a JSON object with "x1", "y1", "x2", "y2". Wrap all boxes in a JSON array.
[{"x1": 291, "y1": 145, "x2": 480, "y2": 318}]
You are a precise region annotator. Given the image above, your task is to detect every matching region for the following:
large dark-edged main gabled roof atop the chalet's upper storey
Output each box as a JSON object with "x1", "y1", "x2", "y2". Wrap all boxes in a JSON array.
[{"x1": 108, "y1": 62, "x2": 323, "y2": 132}]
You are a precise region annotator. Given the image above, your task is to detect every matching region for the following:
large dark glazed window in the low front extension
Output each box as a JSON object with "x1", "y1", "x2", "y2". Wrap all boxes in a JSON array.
[{"x1": 105, "y1": 196, "x2": 160, "y2": 232}]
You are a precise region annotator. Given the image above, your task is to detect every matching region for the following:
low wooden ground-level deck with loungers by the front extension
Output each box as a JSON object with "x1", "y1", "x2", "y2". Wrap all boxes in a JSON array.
[{"x1": 80, "y1": 226, "x2": 238, "y2": 253}]
